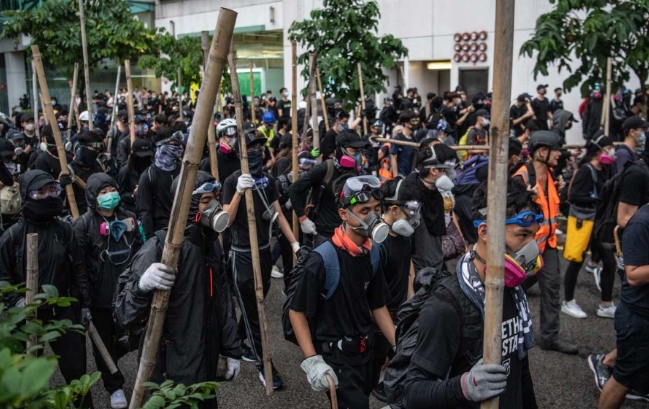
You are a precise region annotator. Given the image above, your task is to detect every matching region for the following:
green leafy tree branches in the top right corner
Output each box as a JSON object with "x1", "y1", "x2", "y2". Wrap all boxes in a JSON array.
[{"x1": 520, "y1": 0, "x2": 649, "y2": 100}]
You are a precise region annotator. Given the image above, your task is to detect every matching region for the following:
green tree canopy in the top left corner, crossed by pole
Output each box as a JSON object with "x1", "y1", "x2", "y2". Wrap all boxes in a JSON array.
[{"x1": 0, "y1": 0, "x2": 156, "y2": 69}]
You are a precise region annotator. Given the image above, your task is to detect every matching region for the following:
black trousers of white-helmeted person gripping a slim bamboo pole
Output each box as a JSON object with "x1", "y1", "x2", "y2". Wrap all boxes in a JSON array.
[{"x1": 230, "y1": 246, "x2": 273, "y2": 361}]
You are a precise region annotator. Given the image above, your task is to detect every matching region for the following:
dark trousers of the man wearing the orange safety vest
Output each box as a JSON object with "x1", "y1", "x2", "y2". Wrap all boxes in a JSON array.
[{"x1": 523, "y1": 247, "x2": 561, "y2": 342}]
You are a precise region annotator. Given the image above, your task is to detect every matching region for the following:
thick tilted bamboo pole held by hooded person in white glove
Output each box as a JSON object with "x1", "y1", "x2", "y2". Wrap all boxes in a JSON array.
[{"x1": 129, "y1": 8, "x2": 237, "y2": 409}]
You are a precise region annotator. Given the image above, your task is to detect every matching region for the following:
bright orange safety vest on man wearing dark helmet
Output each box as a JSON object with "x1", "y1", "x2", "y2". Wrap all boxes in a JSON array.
[{"x1": 514, "y1": 166, "x2": 560, "y2": 253}]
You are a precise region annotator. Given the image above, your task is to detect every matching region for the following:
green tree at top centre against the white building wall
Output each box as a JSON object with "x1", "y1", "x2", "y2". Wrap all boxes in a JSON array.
[{"x1": 289, "y1": 0, "x2": 408, "y2": 109}]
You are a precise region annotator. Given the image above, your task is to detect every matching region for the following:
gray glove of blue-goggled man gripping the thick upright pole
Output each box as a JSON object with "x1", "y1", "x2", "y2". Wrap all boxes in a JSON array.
[{"x1": 462, "y1": 359, "x2": 507, "y2": 402}]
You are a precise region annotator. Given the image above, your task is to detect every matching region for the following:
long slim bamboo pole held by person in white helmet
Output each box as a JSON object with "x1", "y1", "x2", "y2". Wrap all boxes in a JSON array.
[{"x1": 228, "y1": 38, "x2": 273, "y2": 395}]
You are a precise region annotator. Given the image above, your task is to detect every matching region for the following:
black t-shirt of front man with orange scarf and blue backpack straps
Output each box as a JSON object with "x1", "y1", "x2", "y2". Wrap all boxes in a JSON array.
[{"x1": 290, "y1": 245, "x2": 386, "y2": 342}]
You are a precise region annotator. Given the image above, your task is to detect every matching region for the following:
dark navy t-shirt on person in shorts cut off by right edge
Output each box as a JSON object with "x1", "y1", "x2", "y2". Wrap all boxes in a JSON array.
[{"x1": 620, "y1": 205, "x2": 649, "y2": 320}]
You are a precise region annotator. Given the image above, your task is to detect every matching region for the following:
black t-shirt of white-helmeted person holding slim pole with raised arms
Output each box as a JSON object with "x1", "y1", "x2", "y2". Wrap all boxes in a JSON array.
[{"x1": 222, "y1": 170, "x2": 278, "y2": 248}]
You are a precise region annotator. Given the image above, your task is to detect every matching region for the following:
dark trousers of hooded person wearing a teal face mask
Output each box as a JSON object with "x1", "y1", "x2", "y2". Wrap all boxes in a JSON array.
[{"x1": 90, "y1": 308, "x2": 126, "y2": 394}]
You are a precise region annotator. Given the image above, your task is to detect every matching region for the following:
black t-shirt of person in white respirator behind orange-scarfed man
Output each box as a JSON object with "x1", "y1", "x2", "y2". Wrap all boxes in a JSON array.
[{"x1": 381, "y1": 235, "x2": 412, "y2": 311}]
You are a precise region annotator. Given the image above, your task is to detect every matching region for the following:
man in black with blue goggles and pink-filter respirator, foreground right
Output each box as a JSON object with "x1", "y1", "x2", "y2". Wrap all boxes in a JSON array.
[{"x1": 404, "y1": 179, "x2": 542, "y2": 409}]
